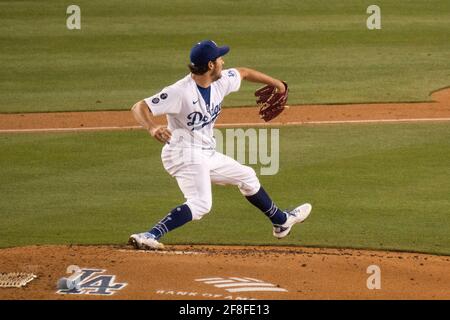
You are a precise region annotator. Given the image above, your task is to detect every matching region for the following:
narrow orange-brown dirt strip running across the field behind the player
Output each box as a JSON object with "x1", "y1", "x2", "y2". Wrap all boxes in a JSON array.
[{"x1": 0, "y1": 88, "x2": 450, "y2": 133}]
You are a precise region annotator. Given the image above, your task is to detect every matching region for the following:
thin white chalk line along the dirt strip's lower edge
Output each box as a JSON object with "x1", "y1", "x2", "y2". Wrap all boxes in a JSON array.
[{"x1": 0, "y1": 118, "x2": 450, "y2": 133}]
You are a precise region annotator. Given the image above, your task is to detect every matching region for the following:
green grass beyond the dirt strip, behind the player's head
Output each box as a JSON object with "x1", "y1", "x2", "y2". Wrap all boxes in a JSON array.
[{"x1": 0, "y1": 0, "x2": 450, "y2": 112}]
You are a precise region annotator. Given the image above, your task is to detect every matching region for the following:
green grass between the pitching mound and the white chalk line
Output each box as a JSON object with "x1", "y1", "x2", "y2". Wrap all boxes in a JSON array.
[{"x1": 0, "y1": 123, "x2": 450, "y2": 255}]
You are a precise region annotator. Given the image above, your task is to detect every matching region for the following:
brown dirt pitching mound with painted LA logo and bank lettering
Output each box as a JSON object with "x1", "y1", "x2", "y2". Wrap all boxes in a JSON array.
[{"x1": 0, "y1": 246, "x2": 450, "y2": 300}]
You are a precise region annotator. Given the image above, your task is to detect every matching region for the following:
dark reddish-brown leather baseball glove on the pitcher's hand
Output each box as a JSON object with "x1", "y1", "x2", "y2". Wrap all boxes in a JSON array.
[{"x1": 255, "y1": 81, "x2": 289, "y2": 122}]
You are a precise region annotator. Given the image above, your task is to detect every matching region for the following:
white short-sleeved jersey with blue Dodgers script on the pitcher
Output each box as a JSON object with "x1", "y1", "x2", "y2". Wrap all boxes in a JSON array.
[{"x1": 144, "y1": 69, "x2": 241, "y2": 149}]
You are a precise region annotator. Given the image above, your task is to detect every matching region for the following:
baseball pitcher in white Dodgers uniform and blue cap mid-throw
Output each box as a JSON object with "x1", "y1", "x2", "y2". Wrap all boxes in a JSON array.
[{"x1": 129, "y1": 40, "x2": 312, "y2": 250}]
